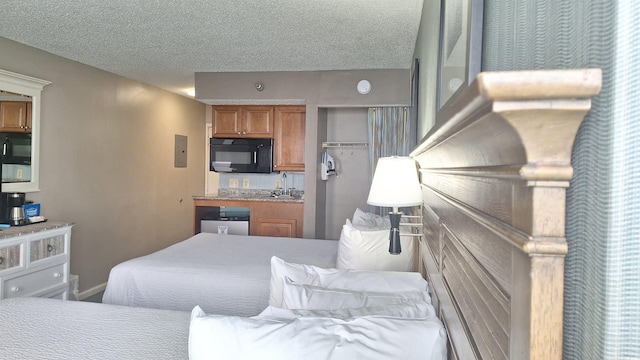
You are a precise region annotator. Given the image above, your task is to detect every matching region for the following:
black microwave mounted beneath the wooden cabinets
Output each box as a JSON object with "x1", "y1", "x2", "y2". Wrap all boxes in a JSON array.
[{"x1": 209, "y1": 138, "x2": 273, "y2": 173}]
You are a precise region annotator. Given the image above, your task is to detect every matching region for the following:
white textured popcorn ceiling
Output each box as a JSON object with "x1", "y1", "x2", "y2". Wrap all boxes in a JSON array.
[{"x1": 0, "y1": 0, "x2": 423, "y2": 94}]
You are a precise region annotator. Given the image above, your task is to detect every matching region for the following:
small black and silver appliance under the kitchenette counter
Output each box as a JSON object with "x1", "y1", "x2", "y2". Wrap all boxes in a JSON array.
[{"x1": 200, "y1": 206, "x2": 250, "y2": 235}]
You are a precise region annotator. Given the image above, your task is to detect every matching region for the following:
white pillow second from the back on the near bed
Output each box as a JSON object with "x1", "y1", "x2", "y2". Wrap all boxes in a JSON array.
[{"x1": 282, "y1": 279, "x2": 431, "y2": 310}]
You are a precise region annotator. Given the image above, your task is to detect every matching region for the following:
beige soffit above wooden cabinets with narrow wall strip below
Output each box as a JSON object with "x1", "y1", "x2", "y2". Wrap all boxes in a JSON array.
[{"x1": 196, "y1": 69, "x2": 411, "y2": 238}]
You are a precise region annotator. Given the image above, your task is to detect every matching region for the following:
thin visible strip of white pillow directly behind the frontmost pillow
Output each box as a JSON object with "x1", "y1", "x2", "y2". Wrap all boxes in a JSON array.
[{"x1": 256, "y1": 301, "x2": 436, "y2": 319}]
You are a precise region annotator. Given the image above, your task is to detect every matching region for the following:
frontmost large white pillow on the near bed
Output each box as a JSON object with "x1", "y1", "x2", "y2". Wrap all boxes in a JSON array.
[{"x1": 189, "y1": 307, "x2": 446, "y2": 360}]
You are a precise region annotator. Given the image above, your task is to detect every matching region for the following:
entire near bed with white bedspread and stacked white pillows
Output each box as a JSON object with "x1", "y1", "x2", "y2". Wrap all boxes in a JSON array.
[{"x1": 0, "y1": 257, "x2": 446, "y2": 360}]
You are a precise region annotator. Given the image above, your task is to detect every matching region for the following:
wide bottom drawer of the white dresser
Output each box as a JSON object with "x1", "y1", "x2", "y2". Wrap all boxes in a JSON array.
[{"x1": 2, "y1": 264, "x2": 65, "y2": 298}]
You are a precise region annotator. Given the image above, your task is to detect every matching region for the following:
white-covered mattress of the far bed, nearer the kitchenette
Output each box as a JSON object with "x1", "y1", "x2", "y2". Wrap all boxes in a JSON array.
[{"x1": 102, "y1": 233, "x2": 338, "y2": 316}]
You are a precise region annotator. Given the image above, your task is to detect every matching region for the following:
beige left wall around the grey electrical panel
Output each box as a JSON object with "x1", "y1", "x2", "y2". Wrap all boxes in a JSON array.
[{"x1": 0, "y1": 38, "x2": 206, "y2": 294}]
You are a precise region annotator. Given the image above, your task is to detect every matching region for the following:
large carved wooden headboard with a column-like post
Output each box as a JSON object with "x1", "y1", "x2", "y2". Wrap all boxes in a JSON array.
[{"x1": 411, "y1": 69, "x2": 601, "y2": 360}]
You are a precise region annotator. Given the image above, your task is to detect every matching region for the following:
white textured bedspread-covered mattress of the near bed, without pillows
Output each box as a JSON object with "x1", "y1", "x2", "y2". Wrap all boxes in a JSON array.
[{"x1": 0, "y1": 298, "x2": 190, "y2": 360}]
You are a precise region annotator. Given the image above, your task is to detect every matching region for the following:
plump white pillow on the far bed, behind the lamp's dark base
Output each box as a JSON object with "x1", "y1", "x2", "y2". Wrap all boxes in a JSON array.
[{"x1": 336, "y1": 220, "x2": 415, "y2": 271}]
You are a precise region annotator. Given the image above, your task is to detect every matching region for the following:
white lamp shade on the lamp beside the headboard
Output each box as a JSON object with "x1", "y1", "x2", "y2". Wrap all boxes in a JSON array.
[{"x1": 367, "y1": 156, "x2": 422, "y2": 207}]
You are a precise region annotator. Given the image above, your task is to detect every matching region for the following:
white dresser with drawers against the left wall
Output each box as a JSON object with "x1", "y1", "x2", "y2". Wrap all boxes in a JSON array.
[{"x1": 0, "y1": 222, "x2": 73, "y2": 300}]
